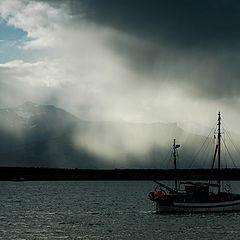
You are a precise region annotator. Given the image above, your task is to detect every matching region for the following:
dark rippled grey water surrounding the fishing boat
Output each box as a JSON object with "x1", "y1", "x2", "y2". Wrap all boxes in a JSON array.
[{"x1": 0, "y1": 182, "x2": 240, "y2": 240}]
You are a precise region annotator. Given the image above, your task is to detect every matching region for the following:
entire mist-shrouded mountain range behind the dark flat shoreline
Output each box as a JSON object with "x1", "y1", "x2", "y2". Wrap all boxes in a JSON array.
[{"x1": 0, "y1": 102, "x2": 238, "y2": 168}]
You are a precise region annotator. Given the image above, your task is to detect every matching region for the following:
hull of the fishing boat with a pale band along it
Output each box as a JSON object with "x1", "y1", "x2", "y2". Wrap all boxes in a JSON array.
[{"x1": 156, "y1": 200, "x2": 240, "y2": 213}]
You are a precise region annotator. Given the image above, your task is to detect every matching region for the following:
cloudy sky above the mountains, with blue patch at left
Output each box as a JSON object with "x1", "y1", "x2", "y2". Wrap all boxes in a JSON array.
[{"x1": 0, "y1": 0, "x2": 240, "y2": 133}]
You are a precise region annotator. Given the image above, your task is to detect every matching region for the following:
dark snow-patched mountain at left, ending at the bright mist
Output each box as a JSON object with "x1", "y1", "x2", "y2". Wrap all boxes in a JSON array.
[{"x1": 0, "y1": 102, "x2": 95, "y2": 168}]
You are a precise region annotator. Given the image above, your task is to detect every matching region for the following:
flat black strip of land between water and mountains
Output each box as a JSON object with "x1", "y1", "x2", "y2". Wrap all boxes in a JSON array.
[{"x1": 0, "y1": 167, "x2": 240, "y2": 181}]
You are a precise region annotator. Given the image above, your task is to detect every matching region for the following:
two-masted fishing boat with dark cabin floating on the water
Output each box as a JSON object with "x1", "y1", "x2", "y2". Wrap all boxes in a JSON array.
[{"x1": 148, "y1": 112, "x2": 240, "y2": 213}]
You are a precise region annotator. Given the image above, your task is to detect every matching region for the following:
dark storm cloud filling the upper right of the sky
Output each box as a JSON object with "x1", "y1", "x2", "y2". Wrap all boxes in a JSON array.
[{"x1": 66, "y1": 0, "x2": 240, "y2": 99}]
